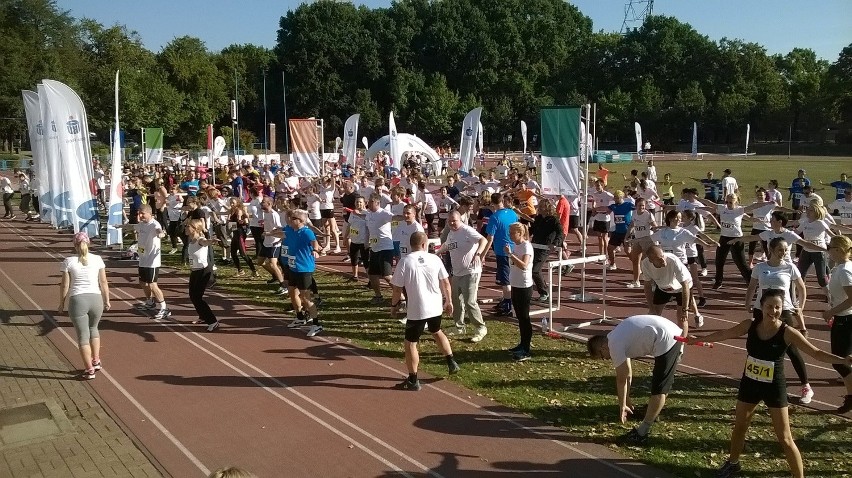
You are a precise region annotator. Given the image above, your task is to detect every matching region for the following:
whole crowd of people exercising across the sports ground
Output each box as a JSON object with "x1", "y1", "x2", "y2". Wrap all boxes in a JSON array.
[{"x1": 0, "y1": 153, "x2": 852, "y2": 476}]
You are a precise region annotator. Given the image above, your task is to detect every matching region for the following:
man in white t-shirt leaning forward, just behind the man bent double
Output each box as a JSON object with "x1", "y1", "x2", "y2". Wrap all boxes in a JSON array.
[{"x1": 640, "y1": 246, "x2": 702, "y2": 334}]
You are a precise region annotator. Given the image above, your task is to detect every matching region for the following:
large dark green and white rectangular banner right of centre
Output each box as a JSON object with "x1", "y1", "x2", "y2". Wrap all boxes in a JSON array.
[{"x1": 541, "y1": 107, "x2": 580, "y2": 196}]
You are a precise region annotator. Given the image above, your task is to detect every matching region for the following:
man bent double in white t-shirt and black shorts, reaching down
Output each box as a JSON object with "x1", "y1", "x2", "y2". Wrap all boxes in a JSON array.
[{"x1": 587, "y1": 314, "x2": 686, "y2": 445}]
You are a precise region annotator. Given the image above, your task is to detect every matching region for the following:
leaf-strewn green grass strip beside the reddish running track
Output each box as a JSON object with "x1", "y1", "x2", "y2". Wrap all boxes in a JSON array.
[{"x1": 163, "y1": 248, "x2": 852, "y2": 477}]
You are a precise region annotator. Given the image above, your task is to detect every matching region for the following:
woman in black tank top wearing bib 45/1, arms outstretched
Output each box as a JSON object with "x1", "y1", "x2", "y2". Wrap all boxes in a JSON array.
[{"x1": 694, "y1": 289, "x2": 852, "y2": 478}]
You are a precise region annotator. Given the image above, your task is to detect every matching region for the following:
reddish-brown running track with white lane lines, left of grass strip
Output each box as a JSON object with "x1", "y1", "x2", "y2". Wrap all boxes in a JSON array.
[{"x1": 0, "y1": 221, "x2": 672, "y2": 478}]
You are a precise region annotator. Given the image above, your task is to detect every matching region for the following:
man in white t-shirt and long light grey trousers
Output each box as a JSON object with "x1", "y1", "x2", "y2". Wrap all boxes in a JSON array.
[{"x1": 436, "y1": 211, "x2": 488, "y2": 343}]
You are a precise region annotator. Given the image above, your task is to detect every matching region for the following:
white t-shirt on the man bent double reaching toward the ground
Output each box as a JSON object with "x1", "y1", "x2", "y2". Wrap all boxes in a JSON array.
[{"x1": 606, "y1": 315, "x2": 683, "y2": 367}]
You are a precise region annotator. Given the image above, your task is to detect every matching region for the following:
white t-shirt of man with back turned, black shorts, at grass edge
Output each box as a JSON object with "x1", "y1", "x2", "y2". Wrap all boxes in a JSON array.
[{"x1": 391, "y1": 251, "x2": 449, "y2": 320}]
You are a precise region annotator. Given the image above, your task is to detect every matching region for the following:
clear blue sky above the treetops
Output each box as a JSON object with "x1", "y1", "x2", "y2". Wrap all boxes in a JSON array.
[{"x1": 56, "y1": 0, "x2": 852, "y2": 62}]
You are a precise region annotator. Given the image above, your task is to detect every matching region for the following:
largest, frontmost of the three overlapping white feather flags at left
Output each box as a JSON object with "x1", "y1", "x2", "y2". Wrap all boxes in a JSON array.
[{"x1": 43, "y1": 80, "x2": 99, "y2": 237}]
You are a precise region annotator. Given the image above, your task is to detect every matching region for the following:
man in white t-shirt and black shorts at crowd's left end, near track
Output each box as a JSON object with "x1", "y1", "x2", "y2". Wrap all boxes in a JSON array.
[{"x1": 117, "y1": 204, "x2": 172, "y2": 320}]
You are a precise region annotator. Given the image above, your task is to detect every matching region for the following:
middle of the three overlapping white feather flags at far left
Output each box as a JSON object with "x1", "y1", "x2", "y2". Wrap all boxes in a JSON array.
[{"x1": 38, "y1": 83, "x2": 63, "y2": 227}]
